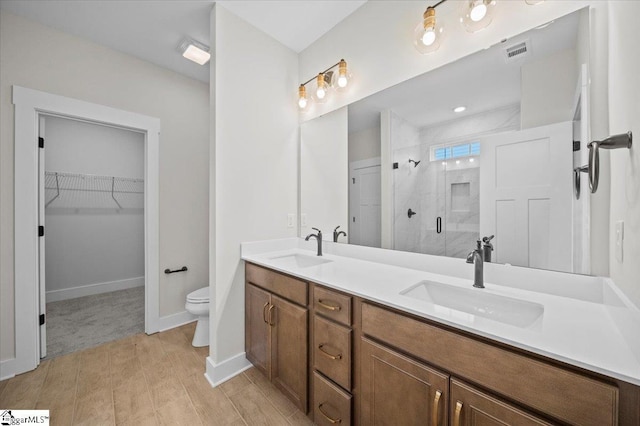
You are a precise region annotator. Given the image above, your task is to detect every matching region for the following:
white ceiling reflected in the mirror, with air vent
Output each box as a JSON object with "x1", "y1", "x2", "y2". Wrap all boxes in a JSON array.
[{"x1": 349, "y1": 13, "x2": 579, "y2": 132}]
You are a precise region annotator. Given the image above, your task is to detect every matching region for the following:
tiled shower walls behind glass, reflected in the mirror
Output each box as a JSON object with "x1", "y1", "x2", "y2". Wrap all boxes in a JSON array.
[{"x1": 391, "y1": 105, "x2": 520, "y2": 258}]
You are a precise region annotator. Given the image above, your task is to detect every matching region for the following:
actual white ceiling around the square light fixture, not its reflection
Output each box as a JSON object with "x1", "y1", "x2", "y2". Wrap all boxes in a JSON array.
[{"x1": 0, "y1": 0, "x2": 366, "y2": 82}]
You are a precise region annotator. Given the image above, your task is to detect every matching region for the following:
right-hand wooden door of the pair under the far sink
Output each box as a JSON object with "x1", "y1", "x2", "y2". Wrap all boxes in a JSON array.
[{"x1": 269, "y1": 295, "x2": 309, "y2": 413}]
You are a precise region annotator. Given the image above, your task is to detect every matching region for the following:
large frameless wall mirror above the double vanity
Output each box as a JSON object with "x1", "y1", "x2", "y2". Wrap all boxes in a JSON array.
[{"x1": 301, "y1": 9, "x2": 596, "y2": 274}]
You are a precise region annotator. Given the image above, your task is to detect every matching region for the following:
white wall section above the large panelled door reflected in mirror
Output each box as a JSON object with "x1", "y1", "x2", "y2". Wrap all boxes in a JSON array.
[{"x1": 520, "y1": 49, "x2": 579, "y2": 129}]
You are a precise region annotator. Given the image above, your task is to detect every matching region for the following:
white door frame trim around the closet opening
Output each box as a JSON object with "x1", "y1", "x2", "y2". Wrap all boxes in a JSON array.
[{"x1": 8, "y1": 86, "x2": 160, "y2": 377}]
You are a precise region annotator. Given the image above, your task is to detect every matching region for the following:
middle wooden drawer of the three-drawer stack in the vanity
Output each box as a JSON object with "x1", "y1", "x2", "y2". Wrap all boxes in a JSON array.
[{"x1": 313, "y1": 315, "x2": 351, "y2": 390}]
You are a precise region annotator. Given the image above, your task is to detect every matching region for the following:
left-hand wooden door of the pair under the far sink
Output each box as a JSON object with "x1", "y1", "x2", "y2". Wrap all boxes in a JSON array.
[{"x1": 244, "y1": 284, "x2": 271, "y2": 379}]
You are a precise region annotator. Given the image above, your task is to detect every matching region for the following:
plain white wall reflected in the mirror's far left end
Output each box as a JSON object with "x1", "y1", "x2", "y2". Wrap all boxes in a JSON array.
[{"x1": 300, "y1": 108, "x2": 349, "y2": 241}]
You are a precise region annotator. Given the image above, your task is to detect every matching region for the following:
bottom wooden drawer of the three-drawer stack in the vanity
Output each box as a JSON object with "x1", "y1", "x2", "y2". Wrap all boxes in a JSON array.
[{"x1": 313, "y1": 372, "x2": 352, "y2": 426}]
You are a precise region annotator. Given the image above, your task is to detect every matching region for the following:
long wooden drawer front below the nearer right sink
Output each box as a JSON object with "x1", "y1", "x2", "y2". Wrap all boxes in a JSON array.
[{"x1": 362, "y1": 303, "x2": 618, "y2": 426}]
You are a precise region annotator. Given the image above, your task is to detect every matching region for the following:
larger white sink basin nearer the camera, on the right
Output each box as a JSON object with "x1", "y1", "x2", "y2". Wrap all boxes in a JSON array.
[{"x1": 400, "y1": 281, "x2": 544, "y2": 328}]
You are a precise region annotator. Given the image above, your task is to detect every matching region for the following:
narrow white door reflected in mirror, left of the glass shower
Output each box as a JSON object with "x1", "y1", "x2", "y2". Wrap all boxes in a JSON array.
[{"x1": 349, "y1": 161, "x2": 382, "y2": 247}]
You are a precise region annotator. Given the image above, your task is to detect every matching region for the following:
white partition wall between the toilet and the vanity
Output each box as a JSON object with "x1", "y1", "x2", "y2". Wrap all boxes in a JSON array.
[{"x1": 207, "y1": 4, "x2": 299, "y2": 376}]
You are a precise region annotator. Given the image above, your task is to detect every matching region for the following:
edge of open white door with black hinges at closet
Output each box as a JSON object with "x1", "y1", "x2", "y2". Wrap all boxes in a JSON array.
[{"x1": 38, "y1": 115, "x2": 47, "y2": 358}]
